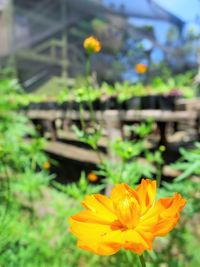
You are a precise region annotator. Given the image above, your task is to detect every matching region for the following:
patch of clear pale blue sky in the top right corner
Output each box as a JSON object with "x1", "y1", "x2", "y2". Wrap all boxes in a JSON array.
[{"x1": 154, "y1": 0, "x2": 200, "y2": 21}]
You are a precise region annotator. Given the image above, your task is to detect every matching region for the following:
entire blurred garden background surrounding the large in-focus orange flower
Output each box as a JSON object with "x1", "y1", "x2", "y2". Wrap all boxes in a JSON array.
[{"x1": 0, "y1": 0, "x2": 200, "y2": 267}]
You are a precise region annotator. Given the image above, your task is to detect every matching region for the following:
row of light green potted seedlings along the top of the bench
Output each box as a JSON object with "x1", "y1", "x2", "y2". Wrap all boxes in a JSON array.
[{"x1": 30, "y1": 71, "x2": 195, "y2": 104}]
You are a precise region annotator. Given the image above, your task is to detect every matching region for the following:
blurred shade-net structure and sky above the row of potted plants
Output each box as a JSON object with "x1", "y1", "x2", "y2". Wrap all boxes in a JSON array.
[{"x1": 0, "y1": 0, "x2": 200, "y2": 91}]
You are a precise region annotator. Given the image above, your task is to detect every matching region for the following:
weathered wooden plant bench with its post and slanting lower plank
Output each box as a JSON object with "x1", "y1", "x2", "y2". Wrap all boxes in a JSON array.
[{"x1": 23, "y1": 103, "x2": 200, "y2": 184}]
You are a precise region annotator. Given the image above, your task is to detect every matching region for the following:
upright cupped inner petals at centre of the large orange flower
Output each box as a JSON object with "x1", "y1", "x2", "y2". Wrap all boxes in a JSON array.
[{"x1": 114, "y1": 194, "x2": 140, "y2": 229}]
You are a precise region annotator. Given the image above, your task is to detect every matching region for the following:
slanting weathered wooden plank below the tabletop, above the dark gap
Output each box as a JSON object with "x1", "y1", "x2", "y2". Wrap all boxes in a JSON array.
[{"x1": 45, "y1": 141, "x2": 105, "y2": 164}]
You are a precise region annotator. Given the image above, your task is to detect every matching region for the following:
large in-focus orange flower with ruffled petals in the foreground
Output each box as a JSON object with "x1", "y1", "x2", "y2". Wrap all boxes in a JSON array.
[{"x1": 70, "y1": 179, "x2": 186, "y2": 255}]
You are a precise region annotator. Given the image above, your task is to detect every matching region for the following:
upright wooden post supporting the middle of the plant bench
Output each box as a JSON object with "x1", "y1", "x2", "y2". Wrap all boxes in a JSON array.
[{"x1": 103, "y1": 110, "x2": 122, "y2": 195}]
